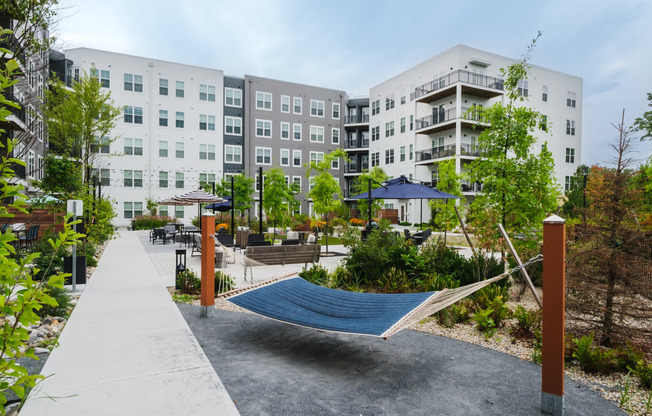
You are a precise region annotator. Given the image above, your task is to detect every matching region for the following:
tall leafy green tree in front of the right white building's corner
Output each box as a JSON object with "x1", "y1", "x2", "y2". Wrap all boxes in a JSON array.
[{"x1": 471, "y1": 34, "x2": 557, "y2": 241}]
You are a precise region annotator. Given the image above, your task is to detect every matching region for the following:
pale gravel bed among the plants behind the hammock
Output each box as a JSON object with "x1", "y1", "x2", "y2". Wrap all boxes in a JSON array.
[{"x1": 205, "y1": 290, "x2": 652, "y2": 416}]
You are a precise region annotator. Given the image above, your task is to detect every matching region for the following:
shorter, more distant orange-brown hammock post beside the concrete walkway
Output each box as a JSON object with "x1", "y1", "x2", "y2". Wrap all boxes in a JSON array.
[{"x1": 200, "y1": 214, "x2": 215, "y2": 317}]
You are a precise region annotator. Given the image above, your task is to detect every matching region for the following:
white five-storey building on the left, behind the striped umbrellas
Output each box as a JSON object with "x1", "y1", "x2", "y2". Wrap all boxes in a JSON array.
[{"x1": 65, "y1": 48, "x2": 224, "y2": 226}]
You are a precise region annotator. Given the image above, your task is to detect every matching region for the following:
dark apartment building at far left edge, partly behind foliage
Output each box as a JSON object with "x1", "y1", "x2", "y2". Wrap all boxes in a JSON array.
[{"x1": 0, "y1": 16, "x2": 49, "y2": 195}]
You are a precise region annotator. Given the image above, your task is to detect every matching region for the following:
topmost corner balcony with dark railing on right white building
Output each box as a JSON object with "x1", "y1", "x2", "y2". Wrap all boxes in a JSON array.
[{"x1": 410, "y1": 69, "x2": 504, "y2": 103}]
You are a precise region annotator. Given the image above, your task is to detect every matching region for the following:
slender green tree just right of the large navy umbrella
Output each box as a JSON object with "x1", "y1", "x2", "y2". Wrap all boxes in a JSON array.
[{"x1": 428, "y1": 159, "x2": 462, "y2": 244}]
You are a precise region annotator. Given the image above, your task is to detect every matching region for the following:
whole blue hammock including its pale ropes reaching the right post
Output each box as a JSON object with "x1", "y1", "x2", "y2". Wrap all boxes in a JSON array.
[{"x1": 218, "y1": 255, "x2": 542, "y2": 339}]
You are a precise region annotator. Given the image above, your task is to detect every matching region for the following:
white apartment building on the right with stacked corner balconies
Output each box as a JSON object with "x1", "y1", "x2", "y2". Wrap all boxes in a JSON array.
[{"x1": 369, "y1": 45, "x2": 582, "y2": 222}]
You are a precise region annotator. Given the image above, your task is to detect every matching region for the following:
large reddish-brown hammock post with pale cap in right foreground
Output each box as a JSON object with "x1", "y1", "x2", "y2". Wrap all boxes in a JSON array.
[{"x1": 541, "y1": 215, "x2": 566, "y2": 416}]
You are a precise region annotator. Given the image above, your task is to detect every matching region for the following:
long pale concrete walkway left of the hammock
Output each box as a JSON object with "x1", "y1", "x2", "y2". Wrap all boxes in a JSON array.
[{"x1": 20, "y1": 232, "x2": 239, "y2": 416}]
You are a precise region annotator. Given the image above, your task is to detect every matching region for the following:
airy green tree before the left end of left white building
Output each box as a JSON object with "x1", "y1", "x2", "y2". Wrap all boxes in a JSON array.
[{"x1": 43, "y1": 66, "x2": 122, "y2": 184}]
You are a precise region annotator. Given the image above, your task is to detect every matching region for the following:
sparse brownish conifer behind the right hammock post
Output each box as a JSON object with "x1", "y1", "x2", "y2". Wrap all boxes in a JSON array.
[{"x1": 567, "y1": 110, "x2": 652, "y2": 346}]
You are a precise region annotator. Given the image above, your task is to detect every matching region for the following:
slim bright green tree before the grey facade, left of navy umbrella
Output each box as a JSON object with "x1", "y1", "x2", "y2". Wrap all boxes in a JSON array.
[{"x1": 306, "y1": 149, "x2": 346, "y2": 254}]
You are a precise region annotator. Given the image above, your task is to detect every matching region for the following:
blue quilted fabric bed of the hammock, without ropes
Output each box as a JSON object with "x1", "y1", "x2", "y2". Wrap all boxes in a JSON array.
[{"x1": 228, "y1": 277, "x2": 439, "y2": 337}]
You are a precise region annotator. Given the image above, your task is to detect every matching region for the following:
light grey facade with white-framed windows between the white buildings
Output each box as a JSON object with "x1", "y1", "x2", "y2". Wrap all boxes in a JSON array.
[{"x1": 244, "y1": 75, "x2": 346, "y2": 215}]
